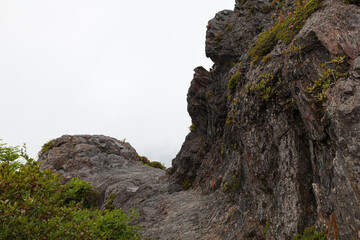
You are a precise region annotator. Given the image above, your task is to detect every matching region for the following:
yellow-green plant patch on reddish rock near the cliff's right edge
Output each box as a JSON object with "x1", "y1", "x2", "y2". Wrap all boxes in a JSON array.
[{"x1": 305, "y1": 57, "x2": 347, "y2": 106}]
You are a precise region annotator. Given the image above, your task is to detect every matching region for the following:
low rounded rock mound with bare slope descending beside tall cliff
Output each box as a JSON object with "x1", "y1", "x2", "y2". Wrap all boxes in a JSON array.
[{"x1": 39, "y1": 135, "x2": 228, "y2": 240}]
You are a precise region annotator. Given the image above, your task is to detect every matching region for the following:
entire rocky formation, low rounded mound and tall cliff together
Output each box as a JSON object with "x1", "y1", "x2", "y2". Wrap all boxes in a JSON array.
[{"x1": 40, "y1": 0, "x2": 360, "y2": 239}]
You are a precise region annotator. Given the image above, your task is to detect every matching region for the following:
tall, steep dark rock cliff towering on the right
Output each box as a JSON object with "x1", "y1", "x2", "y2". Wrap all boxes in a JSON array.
[{"x1": 171, "y1": 0, "x2": 360, "y2": 239}]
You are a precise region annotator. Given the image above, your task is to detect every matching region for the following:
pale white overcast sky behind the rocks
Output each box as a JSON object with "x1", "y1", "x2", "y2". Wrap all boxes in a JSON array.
[{"x1": 0, "y1": 0, "x2": 235, "y2": 167}]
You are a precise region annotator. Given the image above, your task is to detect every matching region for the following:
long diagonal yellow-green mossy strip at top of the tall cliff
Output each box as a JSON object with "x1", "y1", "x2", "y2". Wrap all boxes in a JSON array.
[{"x1": 249, "y1": 0, "x2": 324, "y2": 63}]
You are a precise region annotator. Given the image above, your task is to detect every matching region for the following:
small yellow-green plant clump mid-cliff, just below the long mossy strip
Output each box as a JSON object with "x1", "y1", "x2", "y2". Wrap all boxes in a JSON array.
[{"x1": 245, "y1": 73, "x2": 281, "y2": 101}]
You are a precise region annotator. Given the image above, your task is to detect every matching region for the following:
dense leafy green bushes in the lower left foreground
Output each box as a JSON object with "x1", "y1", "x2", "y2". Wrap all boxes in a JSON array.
[{"x1": 0, "y1": 140, "x2": 140, "y2": 240}]
